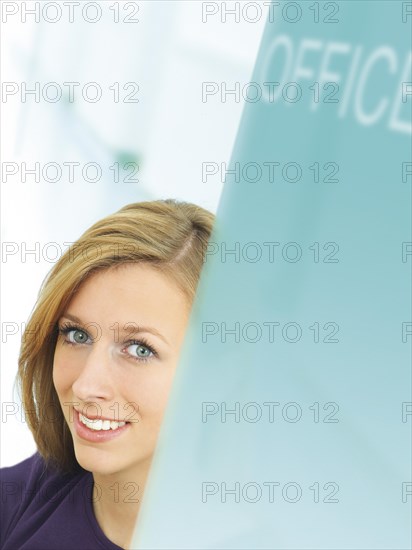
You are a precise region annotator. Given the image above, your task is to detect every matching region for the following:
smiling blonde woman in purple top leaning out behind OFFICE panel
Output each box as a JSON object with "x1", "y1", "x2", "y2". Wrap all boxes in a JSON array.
[{"x1": 0, "y1": 199, "x2": 214, "y2": 550}]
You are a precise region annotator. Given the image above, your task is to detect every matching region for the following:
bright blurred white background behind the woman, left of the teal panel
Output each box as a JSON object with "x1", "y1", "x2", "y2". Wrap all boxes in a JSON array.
[{"x1": 0, "y1": 0, "x2": 268, "y2": 466}]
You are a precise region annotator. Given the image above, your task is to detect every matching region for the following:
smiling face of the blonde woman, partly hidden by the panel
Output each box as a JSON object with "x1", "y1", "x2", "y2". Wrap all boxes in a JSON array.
[{"x1": 53, "y1": 264, "x2": 190, "y2": 475}]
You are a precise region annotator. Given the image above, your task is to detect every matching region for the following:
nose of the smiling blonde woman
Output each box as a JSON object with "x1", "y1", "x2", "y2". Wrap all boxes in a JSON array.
[{"x1": 72, "y1": 341, "x2": 114, "y2": 403}]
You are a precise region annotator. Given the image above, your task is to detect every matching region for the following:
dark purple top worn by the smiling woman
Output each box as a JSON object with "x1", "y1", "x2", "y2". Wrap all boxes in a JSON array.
[{"x1": 0, "y1": 453, "x2": 122, "y2": 550}]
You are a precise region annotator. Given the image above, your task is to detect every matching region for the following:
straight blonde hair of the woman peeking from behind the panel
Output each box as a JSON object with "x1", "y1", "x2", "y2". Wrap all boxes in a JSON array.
[{"x1": 17, "y1": 199, "x2": 214, "y2": 471}]
